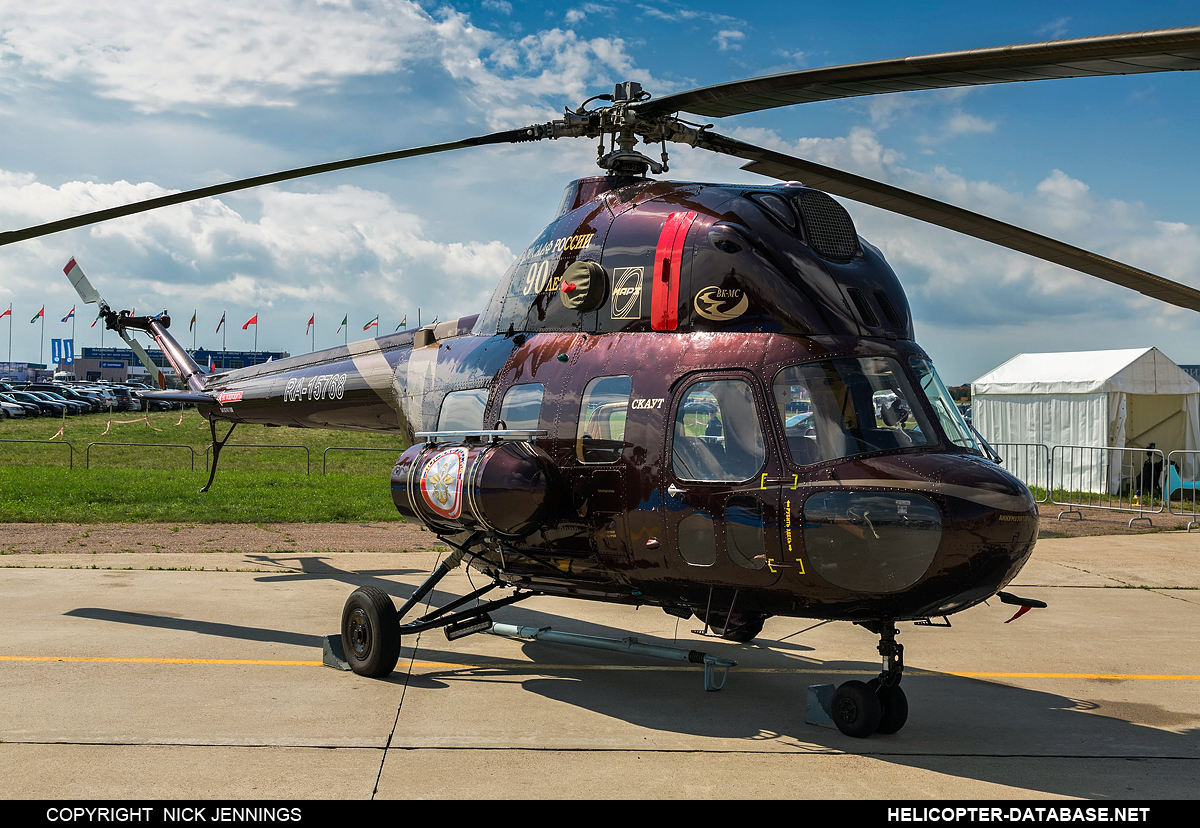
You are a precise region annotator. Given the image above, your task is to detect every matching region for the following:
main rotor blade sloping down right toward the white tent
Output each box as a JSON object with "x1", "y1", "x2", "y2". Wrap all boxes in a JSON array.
[{"x1": 702, "y1": 132, "x2": 1200, "y2": 311}]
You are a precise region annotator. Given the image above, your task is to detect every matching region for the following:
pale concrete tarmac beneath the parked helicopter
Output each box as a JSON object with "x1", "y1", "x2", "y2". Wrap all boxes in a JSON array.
[{"x1": 0, "y1": 527, "x2": 1200, "y2": 799}]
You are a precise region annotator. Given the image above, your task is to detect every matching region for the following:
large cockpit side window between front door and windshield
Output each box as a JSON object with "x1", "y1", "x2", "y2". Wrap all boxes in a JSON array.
[{"x1": 774, "y1": 356, "x2": 936, "y2": 466}]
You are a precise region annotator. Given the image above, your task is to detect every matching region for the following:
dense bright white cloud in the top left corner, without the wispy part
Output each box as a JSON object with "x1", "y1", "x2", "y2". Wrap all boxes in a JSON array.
[{"x1": 0, "y1": 0, "x2": 433, "y2": 112}]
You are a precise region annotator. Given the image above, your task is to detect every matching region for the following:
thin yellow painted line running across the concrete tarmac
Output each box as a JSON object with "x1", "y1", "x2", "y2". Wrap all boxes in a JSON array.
[{"x1": 0, "y1": 655, "x2": 1200, "y2": 682}]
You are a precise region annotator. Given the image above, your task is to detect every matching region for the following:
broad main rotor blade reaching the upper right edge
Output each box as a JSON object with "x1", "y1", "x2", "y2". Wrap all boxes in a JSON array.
[{"x1": 638, "y1": 26, "x2": 1200, "y2": 118}]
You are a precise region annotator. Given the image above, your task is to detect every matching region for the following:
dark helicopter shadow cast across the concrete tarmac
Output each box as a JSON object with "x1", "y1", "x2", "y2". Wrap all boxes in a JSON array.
[{"x1": 65, "y1": 557, "x2": 1200, "y2": 798}]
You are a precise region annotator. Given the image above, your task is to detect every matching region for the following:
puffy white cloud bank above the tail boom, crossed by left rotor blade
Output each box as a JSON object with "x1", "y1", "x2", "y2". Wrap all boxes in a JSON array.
[{"x1": 0, "y1": 172, "x2": 514, "y2": 331}]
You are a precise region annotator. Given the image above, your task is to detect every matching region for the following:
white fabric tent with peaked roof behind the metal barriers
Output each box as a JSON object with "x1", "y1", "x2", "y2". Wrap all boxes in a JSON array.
[{"x1": 971, "y1": 348, "x2": 1200, "y2": 492}]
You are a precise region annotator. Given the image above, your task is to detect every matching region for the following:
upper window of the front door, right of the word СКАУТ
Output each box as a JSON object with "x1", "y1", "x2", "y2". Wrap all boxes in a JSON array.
[{"x1": 671, "y1": 379, "x2": 767, "y2": 482}]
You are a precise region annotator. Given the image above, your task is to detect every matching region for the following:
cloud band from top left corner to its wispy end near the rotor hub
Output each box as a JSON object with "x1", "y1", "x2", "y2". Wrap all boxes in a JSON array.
[{"x1": 0, "y1": 0, "x2": 665, "y2": 124}]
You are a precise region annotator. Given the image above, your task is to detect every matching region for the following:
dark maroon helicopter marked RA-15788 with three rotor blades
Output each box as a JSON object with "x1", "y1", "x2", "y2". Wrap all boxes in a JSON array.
[{"x1": 0, "y1": 26, "x2": 1200, "y2": 738}]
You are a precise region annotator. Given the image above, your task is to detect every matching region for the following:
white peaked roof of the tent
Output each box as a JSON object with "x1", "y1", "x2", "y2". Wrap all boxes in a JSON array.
[{"x1": 971, "y1": 340, "x2": 1200, "y2": 396}]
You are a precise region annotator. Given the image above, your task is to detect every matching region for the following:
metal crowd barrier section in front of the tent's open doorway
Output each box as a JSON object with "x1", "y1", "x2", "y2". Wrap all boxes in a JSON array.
[{"x1": 1050, "y1": 445, "x2": 1166, "y2": 526}]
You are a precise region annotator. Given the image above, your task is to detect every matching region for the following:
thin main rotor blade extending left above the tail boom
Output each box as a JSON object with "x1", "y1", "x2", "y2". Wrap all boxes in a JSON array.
[{"x1": 0, "y1": 128, "x2": 536, "y2": 247}]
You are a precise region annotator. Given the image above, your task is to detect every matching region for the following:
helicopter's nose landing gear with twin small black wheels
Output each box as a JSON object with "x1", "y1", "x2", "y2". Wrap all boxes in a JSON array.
[{"x1": 832, "y1": 620, "x2": 908, "y2": 739}]
